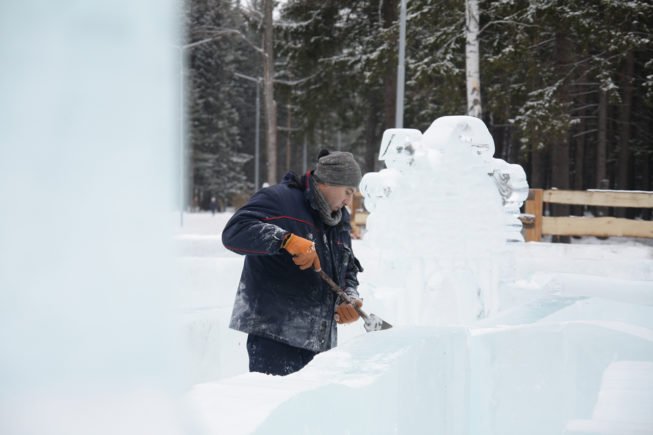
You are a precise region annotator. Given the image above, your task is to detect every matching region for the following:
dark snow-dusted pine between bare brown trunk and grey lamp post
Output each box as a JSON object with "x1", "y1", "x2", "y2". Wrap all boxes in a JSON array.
[{"x1": 279, "y1": 0, "x2": 398, "y2": 174}]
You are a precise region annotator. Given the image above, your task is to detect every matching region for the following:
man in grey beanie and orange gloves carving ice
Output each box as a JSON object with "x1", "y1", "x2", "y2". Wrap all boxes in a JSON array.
[{"x1": 222, "y1": 150, "x2": 363, "y2": 375}]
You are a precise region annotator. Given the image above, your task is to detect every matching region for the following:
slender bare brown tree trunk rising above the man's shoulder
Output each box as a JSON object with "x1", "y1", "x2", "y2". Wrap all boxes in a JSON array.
[{"x1": 263, "y1": 0, "x2": 278, "y2": 185}]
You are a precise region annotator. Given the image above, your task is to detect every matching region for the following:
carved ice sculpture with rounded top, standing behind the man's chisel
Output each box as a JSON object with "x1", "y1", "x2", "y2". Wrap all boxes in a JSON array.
[{"x1": 360, "y1": 116, "x2": 528, "y2": 325}]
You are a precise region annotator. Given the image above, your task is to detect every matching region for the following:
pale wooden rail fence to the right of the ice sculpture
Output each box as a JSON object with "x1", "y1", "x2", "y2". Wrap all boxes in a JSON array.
[{"x1": 521, "y1": 189, "x2": 653, "y2": 242}]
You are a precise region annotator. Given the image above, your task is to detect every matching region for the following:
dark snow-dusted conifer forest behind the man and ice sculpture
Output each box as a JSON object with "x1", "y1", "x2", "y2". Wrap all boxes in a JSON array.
[{"x1": 183, "y1": 0, "x2": 653, "y2": 215}]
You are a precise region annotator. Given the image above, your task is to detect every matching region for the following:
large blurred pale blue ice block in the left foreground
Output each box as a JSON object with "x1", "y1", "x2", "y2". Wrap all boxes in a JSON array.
[{"x1": 0, "y1": 0, "x2": 186, "y2": 435}]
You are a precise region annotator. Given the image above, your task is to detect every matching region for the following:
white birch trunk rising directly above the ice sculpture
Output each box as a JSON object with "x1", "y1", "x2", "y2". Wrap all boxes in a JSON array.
[{"x1": 465, "y1": 0, "x2": 482, "y2": 118}]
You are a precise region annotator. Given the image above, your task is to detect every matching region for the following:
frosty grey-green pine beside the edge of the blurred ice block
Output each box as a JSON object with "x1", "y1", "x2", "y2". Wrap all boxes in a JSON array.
[{"x1": 187, "y1": 0, "x2": 251, "y2": 207}]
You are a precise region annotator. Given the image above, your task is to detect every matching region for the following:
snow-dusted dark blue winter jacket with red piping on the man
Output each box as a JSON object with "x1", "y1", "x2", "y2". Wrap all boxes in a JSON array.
[{"x1": 222, "y1": 172, "x2": 362, "y2": 352}]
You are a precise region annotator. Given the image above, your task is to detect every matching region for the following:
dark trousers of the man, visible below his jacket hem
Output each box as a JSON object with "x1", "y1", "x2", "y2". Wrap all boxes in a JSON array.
[{"x1": 247, "y1": 334, "x2": 317, "y2": 376}]
